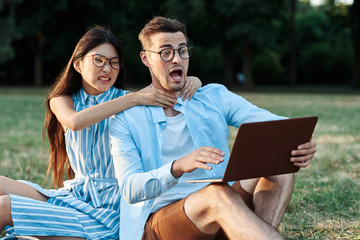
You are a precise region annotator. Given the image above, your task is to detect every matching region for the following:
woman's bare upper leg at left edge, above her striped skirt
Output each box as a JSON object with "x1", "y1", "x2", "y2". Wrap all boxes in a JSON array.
[{"x1": 0, "y1": 176, "x2": 48, "y2": 202}]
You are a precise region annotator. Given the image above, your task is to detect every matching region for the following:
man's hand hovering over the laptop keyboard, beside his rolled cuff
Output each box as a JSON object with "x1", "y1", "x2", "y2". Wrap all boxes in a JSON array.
[{"x1": 171, "y1": 147, "x2": 225, "y2": 178}]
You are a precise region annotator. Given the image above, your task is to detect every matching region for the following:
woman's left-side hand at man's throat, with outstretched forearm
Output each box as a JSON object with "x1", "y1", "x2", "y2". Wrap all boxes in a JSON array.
[{"x1": 135, "y1": 85, "x2": 177, "y2": 107}]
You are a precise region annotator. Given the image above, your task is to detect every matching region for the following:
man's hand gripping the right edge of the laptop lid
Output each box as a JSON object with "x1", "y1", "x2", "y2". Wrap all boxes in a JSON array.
[{"x1": 290, "y1": 138, "x2": 316, "y2": 167}]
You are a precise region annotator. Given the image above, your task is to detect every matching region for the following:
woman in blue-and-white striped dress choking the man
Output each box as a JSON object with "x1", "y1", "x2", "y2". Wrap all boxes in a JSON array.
[{"x1": 0, "y1": 27, "x2": 201, "y2": 239}]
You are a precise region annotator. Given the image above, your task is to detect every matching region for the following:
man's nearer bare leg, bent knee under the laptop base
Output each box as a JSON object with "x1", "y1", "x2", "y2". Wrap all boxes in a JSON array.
[{"x1": 184, "y1": 184, "x2": 283, "y2": 240}]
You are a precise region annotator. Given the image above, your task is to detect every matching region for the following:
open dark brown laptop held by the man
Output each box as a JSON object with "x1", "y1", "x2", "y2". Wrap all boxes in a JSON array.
[{"x1": 187, "y1": 116, "x2": 318, "y2": 183}]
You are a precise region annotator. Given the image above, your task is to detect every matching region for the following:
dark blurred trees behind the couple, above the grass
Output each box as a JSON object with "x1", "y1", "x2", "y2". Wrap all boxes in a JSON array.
[{"x1": 0, "y1": 0, "x2": 360, "y2": 89}]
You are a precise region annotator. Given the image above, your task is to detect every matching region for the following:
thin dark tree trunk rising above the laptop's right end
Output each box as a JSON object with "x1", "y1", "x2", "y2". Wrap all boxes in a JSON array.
[{"x1": 289, "y1": 0, "x2": 297, "y2": 86}]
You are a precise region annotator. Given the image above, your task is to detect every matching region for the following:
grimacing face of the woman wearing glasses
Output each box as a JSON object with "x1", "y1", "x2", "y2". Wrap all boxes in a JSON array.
[{"x1": 74, "y1": 43, "x2": 119, "y2": 95}]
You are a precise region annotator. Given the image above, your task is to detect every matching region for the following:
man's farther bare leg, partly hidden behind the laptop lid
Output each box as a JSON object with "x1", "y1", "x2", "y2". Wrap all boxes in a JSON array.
[{"x1": 240, "y1": 174, "x2": 294, "y2": 229}]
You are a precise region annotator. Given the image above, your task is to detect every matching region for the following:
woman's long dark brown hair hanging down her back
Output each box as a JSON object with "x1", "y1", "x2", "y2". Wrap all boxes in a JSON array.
[{"x1": 43, "y1": 26, "x2": 125, "y2": 187}]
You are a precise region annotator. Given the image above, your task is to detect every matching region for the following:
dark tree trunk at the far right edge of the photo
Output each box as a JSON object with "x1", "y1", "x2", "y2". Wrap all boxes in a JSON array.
[{"x1": 350, "y1": 0, "x2": 360, "y2": 88}]
